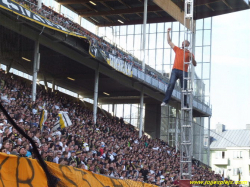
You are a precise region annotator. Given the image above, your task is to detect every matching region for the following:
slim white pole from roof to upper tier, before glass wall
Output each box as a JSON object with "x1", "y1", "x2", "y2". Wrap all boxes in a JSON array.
[{"x1": 142, "y1": 0, "x2": 148, "y2": 72}]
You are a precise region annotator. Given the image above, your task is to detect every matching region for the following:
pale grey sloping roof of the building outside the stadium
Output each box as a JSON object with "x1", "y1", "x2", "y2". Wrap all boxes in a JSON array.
[{"x1": 210, "y1": 129, "x2": 250, "y2": 149}]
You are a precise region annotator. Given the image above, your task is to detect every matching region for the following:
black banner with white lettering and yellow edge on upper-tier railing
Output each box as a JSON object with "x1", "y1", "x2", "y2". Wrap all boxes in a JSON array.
[{"x1": 0, "y1": 0, "x2": 86, "y2": 38}]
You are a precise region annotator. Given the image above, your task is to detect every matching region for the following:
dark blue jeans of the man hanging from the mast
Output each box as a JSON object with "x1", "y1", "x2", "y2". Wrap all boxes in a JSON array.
[{"x1": 163, "y1": 69, "x2": 188, "y2": 106}]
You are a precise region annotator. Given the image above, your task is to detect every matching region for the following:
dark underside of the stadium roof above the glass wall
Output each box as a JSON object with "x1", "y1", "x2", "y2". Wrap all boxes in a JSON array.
[{"x1": 56, "y1": 0, "x2": 249, "y2": 26}]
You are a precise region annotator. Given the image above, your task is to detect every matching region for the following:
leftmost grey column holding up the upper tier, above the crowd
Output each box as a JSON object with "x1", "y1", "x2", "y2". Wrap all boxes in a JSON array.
[{"x1": 32, "y1": 41, "x2": 40, "y2": 101}]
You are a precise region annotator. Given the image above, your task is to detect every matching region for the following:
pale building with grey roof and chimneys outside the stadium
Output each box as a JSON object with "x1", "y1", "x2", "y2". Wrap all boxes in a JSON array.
[{"x1": 210, "y1": 124, "x2": 250, "y2": 181}]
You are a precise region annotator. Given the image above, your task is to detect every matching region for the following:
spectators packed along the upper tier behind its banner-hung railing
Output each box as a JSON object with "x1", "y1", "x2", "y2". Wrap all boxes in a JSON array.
[{"x1": 15, "y1": 0, "x2": 167, "y2": 83}]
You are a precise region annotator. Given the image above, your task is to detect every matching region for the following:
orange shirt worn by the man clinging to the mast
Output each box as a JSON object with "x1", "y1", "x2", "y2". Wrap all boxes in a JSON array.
[{"x1": 173, "y1": 46, "x2": 194, "y2": 72}]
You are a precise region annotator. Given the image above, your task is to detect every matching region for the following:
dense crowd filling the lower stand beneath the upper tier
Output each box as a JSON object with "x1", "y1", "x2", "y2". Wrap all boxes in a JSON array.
[{"x1": 0, "y1": 70, "x2": 236, "y2": 187}]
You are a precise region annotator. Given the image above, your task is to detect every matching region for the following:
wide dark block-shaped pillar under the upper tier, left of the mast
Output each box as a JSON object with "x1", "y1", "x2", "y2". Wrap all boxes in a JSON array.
[{"x1": 144, "y1": 104, "x2": 161, "y2": 138}]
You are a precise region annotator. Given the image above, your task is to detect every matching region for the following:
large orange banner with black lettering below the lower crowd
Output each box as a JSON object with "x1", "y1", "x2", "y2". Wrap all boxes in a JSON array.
[{"x1": 0, "y1": 153, "x2": 156, "y2": 187}]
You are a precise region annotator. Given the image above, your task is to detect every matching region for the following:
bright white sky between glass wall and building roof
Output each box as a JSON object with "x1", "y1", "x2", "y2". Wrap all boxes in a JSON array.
[{"x1": 211, "y1": 10, "x2": 250, "y2": 129}]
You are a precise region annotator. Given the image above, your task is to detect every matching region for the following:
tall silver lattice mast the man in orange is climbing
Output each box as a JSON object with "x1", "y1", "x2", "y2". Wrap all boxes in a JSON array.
[{"x1": 180, "y1": 0, "x2": 195, "y2": 180}]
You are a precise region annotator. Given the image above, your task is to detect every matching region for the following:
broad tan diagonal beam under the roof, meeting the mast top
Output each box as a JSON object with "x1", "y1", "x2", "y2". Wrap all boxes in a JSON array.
[{"x1": 153, "y1": 0, "x2": 190, "y2": 29}]
